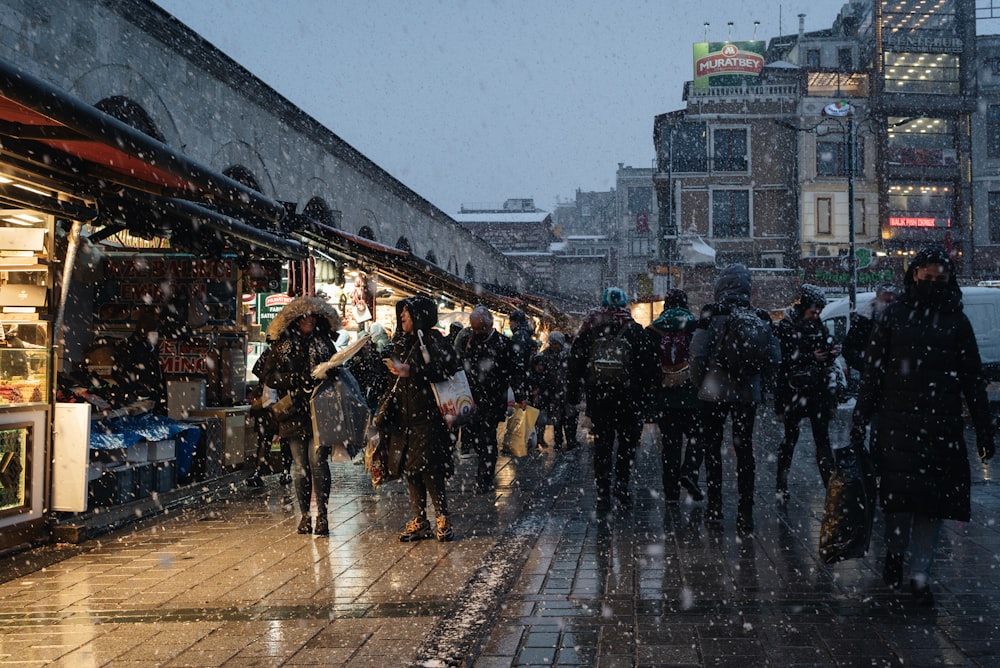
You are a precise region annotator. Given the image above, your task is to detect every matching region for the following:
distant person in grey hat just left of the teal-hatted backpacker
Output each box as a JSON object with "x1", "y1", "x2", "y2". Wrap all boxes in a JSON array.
[{"x1": 532, "y1": 331, "x2": 577, "y2": 450}]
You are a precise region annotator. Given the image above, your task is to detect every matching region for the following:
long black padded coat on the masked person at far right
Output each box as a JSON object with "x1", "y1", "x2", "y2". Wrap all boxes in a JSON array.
[{"x1": 854, "y1": 282, "x2": 993, "y2": 521}]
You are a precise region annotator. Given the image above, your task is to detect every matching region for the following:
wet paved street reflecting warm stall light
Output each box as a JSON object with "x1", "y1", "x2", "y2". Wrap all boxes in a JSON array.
[{"x1": 0, "y1": 410, "x2": 1000, "y2": 668}]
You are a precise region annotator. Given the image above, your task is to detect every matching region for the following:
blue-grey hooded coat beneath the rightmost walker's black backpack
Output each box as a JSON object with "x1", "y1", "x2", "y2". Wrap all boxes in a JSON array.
[{"x1": 691, "y1": 264, "x2": 781, "y2": 404}]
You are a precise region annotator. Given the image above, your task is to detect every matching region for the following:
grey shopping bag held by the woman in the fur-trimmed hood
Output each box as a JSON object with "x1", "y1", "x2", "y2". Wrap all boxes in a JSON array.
[{"x1": 309, "y1": 369, "x2": 369, "y2": 461}]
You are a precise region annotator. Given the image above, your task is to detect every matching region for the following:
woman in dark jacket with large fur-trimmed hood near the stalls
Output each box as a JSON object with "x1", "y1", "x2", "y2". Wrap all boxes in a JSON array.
[{"x1": 260, "y1": 296, "x2": 347, "y2": 536}]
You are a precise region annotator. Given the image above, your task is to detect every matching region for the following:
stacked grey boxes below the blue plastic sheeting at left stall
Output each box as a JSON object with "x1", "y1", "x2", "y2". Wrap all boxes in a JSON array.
[{"x1": 88, "y1": 440, "x2": 177, "y2": 509}]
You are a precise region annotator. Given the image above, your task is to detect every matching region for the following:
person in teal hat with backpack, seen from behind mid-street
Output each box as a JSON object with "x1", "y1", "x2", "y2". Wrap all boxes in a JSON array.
[{"x1": 567, "y1": 288, "x2": 656, "y2": 508}]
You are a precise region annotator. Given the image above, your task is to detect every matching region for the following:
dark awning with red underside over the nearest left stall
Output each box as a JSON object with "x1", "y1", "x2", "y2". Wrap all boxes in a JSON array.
[{"x1": 0, "y1": 60, "x2": 299, "y2": 257}]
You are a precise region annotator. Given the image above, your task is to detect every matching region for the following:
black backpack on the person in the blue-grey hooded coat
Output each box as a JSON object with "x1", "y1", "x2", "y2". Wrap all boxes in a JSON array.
[{"x1": 711, "y1": 306, "x2": 773, "y2": 381}]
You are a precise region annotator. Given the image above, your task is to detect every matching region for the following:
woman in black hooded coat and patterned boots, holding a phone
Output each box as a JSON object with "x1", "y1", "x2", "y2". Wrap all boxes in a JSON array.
[{"x1": 387, "y1": 295, "x2": 458, "y2": 543}]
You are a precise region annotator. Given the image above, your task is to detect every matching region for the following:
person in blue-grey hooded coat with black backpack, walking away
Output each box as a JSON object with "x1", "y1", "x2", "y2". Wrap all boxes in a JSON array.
[{"x1": 691, "y1": 264, "x2": 781, "y2": 536}]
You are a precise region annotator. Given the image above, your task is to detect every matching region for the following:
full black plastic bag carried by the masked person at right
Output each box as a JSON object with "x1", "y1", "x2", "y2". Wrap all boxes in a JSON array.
[{"x1": 819, "y1": 447, "x2": 875, "y2": 564}]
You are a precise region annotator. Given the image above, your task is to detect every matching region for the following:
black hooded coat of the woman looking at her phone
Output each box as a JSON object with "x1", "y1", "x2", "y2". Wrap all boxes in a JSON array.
[{"x1": 389, "y1": 295, "x2": 458, "y2": 477}]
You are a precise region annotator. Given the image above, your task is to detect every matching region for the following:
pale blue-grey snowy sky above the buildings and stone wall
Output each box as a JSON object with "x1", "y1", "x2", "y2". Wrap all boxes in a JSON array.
[{"x1": 155, "y1": 0, "x2": 843, "y2": 214}]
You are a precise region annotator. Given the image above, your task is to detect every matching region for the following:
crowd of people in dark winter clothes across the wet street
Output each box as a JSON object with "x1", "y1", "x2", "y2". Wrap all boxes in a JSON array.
[{"x1": 248, "y1": 247, "x2": 995, "y2": 604}]
